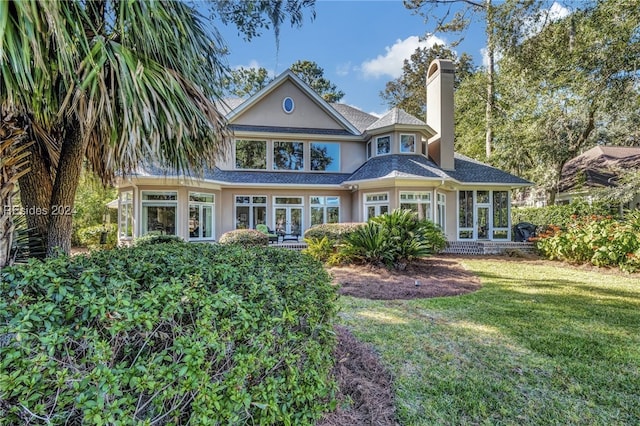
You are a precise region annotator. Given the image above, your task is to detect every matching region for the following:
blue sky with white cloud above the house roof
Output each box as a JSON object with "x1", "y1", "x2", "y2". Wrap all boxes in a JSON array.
[{"x1": 212, "y1": 0, "x2": 484, "y2": 115}]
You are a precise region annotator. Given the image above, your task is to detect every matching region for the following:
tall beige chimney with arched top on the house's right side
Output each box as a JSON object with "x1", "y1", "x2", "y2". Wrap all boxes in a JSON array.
[{"x1": 427, "y1": 59, "x2": 455, "y2": 170}]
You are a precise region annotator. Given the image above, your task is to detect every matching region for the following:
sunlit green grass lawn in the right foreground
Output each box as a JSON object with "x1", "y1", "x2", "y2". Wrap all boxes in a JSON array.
[{"x1": 340, "y1": 258, "x2": 640, "y2": 426}]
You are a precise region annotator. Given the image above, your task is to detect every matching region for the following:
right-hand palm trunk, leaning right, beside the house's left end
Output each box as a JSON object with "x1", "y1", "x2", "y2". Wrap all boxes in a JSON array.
[{"x1": 47, "y1": 126, "x2": 87, "y2": 257}]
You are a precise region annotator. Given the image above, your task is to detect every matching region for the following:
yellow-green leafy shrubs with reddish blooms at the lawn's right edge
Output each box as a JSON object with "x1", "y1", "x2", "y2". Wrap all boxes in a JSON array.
[{"x1": 536, "y1": 211, "x2": 640, "y2": 272}]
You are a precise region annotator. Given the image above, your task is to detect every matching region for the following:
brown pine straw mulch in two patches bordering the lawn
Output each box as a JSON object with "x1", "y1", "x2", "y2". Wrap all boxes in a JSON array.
[{"x1": 317, "y1": 255, "x2": 480, "y2": 426}]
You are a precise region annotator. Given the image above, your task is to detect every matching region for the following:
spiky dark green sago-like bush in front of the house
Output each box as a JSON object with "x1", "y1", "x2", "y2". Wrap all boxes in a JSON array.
[{"x1": 340, "y1": 209, "x2": 446, "y2": 269}]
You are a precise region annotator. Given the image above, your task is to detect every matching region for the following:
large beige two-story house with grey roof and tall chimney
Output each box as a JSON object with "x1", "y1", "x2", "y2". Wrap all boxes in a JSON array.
[{"x1": 118, "y1": 60, "x2": 531, "y2": 246}]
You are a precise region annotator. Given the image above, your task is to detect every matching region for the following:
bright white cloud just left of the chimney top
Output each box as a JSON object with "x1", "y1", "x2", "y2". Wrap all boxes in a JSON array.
[{"x1": 360, "y1": 36, "x2": 445, "y2": 78}]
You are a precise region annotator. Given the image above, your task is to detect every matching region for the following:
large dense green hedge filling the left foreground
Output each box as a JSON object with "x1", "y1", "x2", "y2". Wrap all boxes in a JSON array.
[{"x1": 0, "y1": 244, "x2": 336, "y2": 425}]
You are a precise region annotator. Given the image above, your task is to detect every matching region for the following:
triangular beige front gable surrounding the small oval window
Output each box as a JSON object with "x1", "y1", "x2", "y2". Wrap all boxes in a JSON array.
[{"x1": 227, "y1": 70, "x2": 362, "y2": 135}]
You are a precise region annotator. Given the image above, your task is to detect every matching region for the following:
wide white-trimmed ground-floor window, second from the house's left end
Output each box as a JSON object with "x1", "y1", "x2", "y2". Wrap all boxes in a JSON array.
[{"x1": 140, "y1": 191, "x2": 178, "y2": 235}]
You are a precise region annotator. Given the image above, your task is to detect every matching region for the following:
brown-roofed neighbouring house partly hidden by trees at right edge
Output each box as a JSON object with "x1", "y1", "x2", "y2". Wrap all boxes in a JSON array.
[{"x1": 556, "y1": 146, "x2": 640, "y2": 209}]
